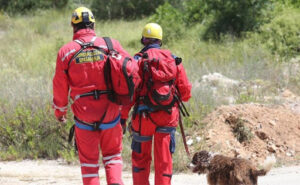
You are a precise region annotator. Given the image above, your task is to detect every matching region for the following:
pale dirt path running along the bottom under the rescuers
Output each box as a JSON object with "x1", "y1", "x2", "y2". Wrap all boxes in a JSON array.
[{"x1": 0, "y1": 161, "x2": 300, "y2": 185}]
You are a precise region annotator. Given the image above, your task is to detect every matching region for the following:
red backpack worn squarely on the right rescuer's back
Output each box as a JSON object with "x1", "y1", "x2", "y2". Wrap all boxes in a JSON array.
[{"x1": 140, "y1": 48, "x2": 181, "y2": 113}]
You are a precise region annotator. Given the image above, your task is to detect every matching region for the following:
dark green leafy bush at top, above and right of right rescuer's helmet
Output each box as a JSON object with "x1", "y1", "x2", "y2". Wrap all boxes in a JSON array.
[{"x1": 154, "y1": 0, "x2": 272, "y2": 40}]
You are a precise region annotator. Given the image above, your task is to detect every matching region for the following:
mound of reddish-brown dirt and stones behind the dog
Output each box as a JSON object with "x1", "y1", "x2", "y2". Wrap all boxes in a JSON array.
[{"x1": 196, "y1": 104, "x2": 300, "y2": 164}]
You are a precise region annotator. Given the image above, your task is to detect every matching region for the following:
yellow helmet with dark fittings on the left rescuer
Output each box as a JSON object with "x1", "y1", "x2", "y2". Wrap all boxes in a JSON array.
[{"x1": 71, "y1": 7, "x2": 95, "y2": 24}]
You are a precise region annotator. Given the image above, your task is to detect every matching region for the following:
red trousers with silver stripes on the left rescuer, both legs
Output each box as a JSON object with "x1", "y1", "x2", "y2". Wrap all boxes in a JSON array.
[{"x1": 75, "y1": 124, "x2": 123, "y2": 185}]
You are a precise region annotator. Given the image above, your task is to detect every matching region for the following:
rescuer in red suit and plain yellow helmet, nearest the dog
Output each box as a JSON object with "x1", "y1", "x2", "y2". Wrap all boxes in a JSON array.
[{"x1": 121, "y1": 23, "x2": 191, "y2": 185}]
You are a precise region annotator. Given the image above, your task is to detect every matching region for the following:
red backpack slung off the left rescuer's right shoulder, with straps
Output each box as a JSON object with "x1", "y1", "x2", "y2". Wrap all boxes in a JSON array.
[{"x1": 68, "y1": 37, "x2": 139, "y2": 105}]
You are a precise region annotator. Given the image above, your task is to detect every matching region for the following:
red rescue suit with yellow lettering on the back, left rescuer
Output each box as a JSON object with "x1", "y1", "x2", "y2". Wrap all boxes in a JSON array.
[{"x1": 53, "y1": 29, "x2": 130, "y2": 185}]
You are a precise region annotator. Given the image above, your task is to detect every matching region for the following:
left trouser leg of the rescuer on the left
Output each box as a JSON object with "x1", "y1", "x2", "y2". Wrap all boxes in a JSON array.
[{"x1": 75, "y1": 127, "x2": 100, "y2": 185}]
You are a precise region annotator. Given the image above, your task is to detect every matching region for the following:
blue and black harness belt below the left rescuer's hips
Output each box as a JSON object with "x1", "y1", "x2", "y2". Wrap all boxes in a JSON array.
[{"x1": 75, "y1": 114, "x2": 121, "y2": 131}]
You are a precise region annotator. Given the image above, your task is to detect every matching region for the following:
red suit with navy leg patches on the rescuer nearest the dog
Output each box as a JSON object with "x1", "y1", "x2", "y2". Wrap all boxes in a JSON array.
[{"x1": 121, "y1": 44, "x2": 192, "y2": 185}]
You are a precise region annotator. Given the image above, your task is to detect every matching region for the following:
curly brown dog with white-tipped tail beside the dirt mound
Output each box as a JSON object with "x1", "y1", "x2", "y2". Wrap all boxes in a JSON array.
[{"x1": 191, "y1": 151, "x2": 276, "y2": 185}]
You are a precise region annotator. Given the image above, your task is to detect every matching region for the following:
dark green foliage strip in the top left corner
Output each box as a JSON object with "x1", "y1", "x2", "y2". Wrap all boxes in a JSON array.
[{"x1": 0, "y1": 0, "x2": 69, "y2": 14}]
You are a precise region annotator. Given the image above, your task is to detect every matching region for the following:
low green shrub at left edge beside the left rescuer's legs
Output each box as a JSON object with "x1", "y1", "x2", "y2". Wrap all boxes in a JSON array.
[{"x1": 0, "y1": 102, "x2": 72, "y2": 160}]
